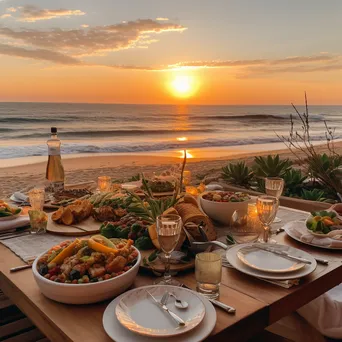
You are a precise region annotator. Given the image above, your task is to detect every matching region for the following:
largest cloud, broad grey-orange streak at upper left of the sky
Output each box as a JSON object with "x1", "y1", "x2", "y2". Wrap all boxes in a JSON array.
[{"x1": 0, "y1": 19, "x2": 186, "y2": 56}]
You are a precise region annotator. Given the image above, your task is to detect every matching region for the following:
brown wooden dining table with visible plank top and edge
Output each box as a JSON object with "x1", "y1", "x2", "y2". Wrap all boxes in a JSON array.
[{"x1": 0, "y1": 206, "x2": 342, "y2": 342}]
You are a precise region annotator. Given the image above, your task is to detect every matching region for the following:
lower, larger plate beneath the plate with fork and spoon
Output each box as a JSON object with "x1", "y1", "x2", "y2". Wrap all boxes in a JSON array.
[{"x1": 102, "y1": 286, "x2": 216, "y2": 342}]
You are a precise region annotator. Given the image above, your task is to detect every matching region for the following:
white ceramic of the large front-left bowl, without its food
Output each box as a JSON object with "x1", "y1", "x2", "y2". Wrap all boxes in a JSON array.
[{"x1": 32, "y1": 246, "x2": 141, "y2": 304}]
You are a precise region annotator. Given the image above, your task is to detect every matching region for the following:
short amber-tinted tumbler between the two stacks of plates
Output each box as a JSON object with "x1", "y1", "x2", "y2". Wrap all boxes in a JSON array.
[{"x1": 195, "y1": 252, "x2": 222, "y2": 299}]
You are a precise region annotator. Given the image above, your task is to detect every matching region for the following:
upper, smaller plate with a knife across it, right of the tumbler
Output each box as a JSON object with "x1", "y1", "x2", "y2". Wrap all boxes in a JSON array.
[{"x1": 237, "y1": 244, "x2": 305, "y2": 273}]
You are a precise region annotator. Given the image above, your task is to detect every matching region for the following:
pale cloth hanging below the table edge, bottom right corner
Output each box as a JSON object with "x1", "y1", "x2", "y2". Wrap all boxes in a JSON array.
[{"x1": 297, "y1": 284, "x2": 342, "y2": 339}]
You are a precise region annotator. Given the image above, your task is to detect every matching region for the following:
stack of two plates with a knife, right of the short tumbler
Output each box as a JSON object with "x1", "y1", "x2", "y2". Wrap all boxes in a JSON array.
[{"x1": 226, "y1": 243, "x2": 317, "y2": 280}]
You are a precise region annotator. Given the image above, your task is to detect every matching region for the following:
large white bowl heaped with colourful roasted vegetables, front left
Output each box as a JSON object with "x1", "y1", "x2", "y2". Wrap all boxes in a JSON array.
[{"x1": 32, "y1": 235, "x2": 141, "y2": 304}]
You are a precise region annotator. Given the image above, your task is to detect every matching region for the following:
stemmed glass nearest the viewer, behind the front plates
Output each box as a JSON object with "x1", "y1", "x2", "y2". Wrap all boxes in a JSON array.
[{"x1": 155, "y1": 214, "x2": 182, "y2": 286}]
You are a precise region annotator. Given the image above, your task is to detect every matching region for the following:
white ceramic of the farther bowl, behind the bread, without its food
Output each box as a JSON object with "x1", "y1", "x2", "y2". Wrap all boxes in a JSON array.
[{"x1": 199, "y1": 191, "x2": 252, "y2": 225}]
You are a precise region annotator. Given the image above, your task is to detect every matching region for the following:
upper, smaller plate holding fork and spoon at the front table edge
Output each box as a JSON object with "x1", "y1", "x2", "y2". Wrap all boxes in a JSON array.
[{"x1": 115, "y1": 286, "x2": 205, "y2": 337}]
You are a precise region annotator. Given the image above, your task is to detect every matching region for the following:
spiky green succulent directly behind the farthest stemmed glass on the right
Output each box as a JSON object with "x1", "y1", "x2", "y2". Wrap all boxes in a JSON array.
[{"x1": 254, "y1": 154, "x2": 292, "y2": 177}]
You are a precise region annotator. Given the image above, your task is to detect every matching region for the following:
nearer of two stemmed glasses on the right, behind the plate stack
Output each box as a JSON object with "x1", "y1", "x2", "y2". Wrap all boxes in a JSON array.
[{"x1": 256, "y1": 195, "x2": 279, "y2": 243}]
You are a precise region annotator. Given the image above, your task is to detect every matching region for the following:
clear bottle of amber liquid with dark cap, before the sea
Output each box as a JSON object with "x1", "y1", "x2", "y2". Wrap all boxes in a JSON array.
[{"x1": 46, "y1": 127, "x2": 64, "y2": 192}]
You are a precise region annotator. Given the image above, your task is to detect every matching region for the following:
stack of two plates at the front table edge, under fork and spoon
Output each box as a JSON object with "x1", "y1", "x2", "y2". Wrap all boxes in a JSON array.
[{"x1": 103, "y1": 285, "x2": 216, "y2": 342}]
